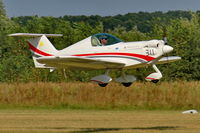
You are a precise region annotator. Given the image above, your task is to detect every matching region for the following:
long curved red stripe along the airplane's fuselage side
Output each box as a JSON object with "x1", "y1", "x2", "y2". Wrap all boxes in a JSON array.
[{"x1": 74, "y1": 53, "x2": 155, "y2": 61}]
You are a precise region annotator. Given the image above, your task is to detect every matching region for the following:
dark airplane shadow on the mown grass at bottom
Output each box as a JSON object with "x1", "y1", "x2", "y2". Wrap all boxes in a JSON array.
[{"x1": 69, "y1": 126, "x2": 179, "y2": 133}]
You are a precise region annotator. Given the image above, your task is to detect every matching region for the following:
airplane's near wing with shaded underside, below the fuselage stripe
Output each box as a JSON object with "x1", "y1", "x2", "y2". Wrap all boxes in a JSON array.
[{"x1": 36, "y1": 56, "x2": 125, "y2": 69}]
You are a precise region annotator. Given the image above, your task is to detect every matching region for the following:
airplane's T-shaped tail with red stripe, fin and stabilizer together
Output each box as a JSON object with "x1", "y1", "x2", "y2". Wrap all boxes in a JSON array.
[{"x1": 9, "y1": 33, "x2": 62, "y2": 68}]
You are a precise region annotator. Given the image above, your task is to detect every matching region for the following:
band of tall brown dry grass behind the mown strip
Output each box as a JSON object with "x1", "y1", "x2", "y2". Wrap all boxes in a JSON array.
[{"x1": 0, "y1": 81, "x2": 200, "y2": 110}]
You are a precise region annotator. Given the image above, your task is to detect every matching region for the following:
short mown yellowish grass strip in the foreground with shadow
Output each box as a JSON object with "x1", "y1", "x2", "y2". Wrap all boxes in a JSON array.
[{"x1": 0, "y1": 109, "x2": 200, "y2": 133}]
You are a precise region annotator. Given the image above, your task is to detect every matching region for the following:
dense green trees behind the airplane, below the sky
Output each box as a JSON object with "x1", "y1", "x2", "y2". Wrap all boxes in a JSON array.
[{"x1": 0, "y1": 0, "x2": 200, "y2": 82}]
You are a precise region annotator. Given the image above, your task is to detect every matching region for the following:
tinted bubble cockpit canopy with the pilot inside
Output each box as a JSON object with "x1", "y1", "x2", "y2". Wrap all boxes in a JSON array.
[{"x1": 91, "y1": 33, "x2": 122, "y2": 46}]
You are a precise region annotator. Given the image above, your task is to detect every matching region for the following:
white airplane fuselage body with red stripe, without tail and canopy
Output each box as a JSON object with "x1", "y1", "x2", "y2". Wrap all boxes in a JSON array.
[{"x1": 57, "y1": 37, "x2": 164, "y2": 68}]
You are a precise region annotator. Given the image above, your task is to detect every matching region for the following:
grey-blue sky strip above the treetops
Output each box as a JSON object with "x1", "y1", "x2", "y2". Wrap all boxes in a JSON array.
[{"x1": 3, "y1": 0, "x2": 200, "y2": 17}]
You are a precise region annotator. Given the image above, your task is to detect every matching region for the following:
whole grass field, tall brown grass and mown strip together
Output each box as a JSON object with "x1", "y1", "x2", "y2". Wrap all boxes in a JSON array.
[{"x1": 0, "y1": 81, "x2": 200, "y2": 133}]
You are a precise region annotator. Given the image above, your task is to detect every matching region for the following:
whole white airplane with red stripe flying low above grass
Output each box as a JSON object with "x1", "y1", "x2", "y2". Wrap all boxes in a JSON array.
[{"x1": 9, "y1": 33, "x2": 181, "y2": 87}]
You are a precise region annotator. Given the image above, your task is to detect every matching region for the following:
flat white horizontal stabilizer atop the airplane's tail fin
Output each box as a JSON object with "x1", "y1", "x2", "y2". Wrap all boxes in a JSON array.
[{"x1": 8, "y1": 33, "x2": 63, "y2": 37}]
